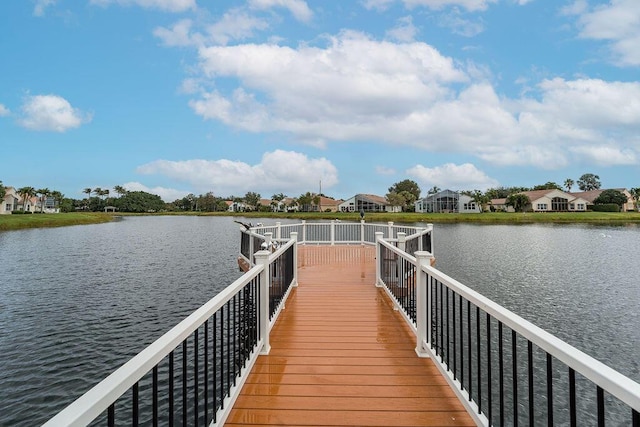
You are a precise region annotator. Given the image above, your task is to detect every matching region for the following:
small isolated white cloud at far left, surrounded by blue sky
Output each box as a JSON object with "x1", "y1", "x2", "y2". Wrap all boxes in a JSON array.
[{"x1": 19, "y1": 95, "x2": 91, "y2": 132}]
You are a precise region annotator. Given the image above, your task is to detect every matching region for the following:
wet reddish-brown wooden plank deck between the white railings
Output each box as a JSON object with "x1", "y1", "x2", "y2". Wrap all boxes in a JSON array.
[{"x1": 225, "y1": 246, "x2": 475, "y2": 426}]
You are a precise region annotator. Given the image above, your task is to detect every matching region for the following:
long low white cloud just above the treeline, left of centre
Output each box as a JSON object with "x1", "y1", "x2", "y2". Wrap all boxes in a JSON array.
[{"x1": 137, "y1": 150, "x2": 338, "y2": 196}]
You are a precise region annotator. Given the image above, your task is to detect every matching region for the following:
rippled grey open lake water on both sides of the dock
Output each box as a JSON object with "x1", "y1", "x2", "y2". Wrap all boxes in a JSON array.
[{"x1": 0, "y1": 216, "x2": 640, "y2": 426}]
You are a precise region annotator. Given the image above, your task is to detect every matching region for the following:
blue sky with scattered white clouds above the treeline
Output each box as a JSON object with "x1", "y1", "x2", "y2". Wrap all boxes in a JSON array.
[{"x1": 0, "y1": 0, "x2": 640, "y2": 201}]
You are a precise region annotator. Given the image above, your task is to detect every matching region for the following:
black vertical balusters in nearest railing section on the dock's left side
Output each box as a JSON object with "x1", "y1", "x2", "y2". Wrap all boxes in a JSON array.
[{"x1": 71, "y1": 275, "x2": 260, "y2": 426}]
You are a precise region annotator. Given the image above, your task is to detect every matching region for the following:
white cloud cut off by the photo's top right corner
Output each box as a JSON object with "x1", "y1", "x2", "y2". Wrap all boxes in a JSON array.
[{"x1": 563, "y1": 0, "x2": 640, "y2": 67}]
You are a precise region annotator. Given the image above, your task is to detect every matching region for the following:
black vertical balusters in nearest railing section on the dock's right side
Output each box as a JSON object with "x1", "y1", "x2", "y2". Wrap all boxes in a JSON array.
[{"x1": 425, "y1": 270, "x2": 636, "y2": 426}]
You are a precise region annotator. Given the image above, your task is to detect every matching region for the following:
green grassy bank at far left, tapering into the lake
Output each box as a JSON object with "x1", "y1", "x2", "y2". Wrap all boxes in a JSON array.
[{"x1": 0, "y1": 212, "x2": 114, "y2": 231}]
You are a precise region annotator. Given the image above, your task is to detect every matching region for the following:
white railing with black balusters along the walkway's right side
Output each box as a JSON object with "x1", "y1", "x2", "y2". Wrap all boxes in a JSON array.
[{"x1": 376, "y1": 234, "x2": 640, "y2": 427}]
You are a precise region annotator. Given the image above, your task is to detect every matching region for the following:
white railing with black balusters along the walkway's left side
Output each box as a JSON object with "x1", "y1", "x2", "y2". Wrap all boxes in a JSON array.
[{"x1": 45, "y1": 233, "x2": 297, "y2": 427}]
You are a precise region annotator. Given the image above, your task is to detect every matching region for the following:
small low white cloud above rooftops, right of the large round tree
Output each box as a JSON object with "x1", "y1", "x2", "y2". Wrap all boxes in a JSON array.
[{"x1": 406, "y1": 163, "x2": 498, "y2": 190}]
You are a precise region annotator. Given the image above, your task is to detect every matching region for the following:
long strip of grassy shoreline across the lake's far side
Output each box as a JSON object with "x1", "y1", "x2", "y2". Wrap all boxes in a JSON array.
[{"x1": 0, "y1": 212, "x2": 640, "y2": 231}]
